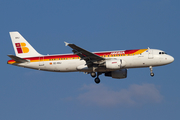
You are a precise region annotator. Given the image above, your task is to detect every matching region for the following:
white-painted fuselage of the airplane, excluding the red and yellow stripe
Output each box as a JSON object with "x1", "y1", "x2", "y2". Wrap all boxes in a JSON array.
[{"x1": 14, "y1": 49, "x2": 174, "y2": 72}]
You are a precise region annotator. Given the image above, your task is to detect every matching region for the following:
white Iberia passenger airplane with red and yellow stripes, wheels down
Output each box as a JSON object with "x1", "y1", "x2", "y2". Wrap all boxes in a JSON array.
[{"x1": 7, "y1": 31, "x2": 174, "y2": 84}]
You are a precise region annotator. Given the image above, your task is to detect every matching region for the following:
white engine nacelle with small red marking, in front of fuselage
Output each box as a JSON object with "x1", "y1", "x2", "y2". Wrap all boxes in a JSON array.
[{"x1": 106, "y1": 59, "x2": 126, "y2": 69}]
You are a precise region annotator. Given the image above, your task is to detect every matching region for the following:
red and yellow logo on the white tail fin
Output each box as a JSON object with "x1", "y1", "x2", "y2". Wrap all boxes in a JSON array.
[{"x1": 15, "y1": 43, "x2": 29, "y2": 54}]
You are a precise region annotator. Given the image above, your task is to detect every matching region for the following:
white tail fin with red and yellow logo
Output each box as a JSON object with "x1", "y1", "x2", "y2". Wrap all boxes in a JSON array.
[{"x1": 9, "y1": 32, "x2": 41, "y2": 58}]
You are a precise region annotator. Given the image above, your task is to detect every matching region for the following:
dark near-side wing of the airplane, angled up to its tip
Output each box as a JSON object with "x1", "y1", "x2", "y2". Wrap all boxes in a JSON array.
[{"x1": 64, "y1": 42, "x2": 105, "y2": 65}]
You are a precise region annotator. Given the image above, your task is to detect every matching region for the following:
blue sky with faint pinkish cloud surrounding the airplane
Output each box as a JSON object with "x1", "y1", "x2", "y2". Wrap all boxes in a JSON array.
[{"x1": 0, "y1": 0, "x2": 180, "y2": 120}]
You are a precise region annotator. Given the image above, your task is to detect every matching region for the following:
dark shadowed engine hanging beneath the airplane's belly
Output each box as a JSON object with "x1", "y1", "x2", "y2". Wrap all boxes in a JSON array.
[{"x1": 105, "y1": 69, "x2": 127, "y2": 79}]
